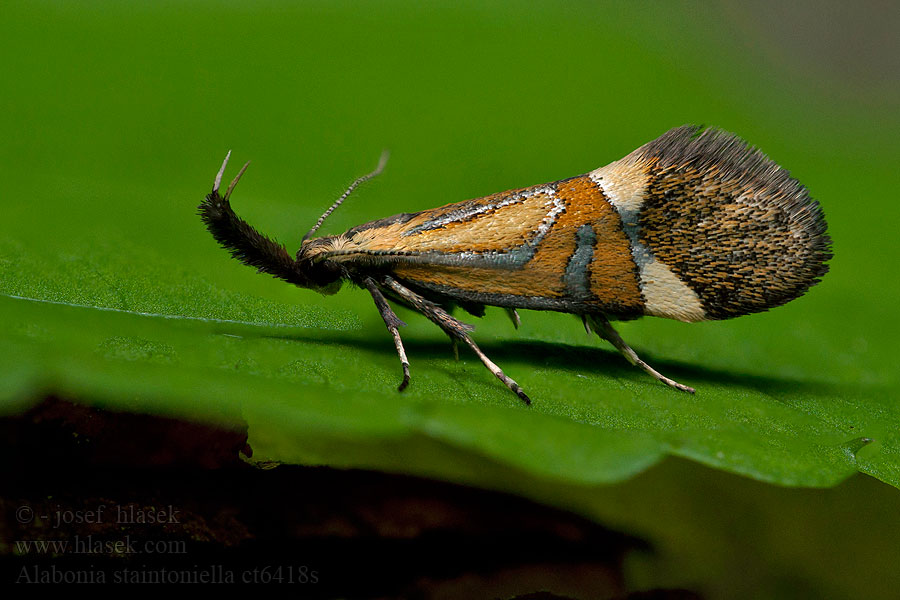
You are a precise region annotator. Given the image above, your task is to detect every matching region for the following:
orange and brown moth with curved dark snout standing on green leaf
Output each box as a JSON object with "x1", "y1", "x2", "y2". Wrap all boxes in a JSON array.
[{"x1": 199, "y1": 126, "x2": 831, "y2": 403}]
